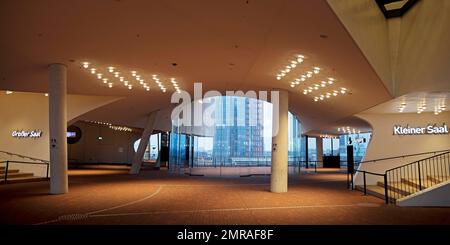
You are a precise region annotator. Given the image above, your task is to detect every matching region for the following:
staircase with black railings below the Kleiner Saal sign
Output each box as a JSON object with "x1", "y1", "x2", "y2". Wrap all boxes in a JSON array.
[{"x1": 355, "y1": 152, "x2": 450, "y2": 203}]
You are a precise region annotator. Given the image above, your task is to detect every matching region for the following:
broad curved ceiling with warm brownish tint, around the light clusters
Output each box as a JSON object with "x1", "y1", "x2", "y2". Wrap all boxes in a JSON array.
[{"x1": 0, "y1": 0, "x2": 391, "y2": 131}]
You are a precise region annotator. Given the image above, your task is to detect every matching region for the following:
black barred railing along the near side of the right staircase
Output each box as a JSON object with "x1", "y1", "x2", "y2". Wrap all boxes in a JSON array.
[{"x1": 386, "y1": 151, "x2": 450, "y2": 204}]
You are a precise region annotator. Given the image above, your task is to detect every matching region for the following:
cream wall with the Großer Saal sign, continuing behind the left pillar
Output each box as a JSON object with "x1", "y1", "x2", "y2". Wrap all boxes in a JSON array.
[{"x1": 0, "y1": 91, "x2": 119, "y2": 174}]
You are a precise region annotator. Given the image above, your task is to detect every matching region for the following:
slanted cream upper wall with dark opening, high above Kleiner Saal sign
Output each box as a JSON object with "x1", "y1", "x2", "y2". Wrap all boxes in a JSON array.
[{"x1": 327, "y1": 0, "x2": 450, "y2": 97}]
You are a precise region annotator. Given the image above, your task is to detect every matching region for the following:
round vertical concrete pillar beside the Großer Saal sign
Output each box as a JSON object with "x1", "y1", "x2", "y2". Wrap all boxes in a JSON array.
[{"x1": 48, "y1": 64, "x2": 69, "y2": 194}]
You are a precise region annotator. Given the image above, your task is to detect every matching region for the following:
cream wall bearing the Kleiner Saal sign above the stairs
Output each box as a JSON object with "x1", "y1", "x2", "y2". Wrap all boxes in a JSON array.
[{"x1": 355, "y1": 112, "x2": 450, "y2": 185}]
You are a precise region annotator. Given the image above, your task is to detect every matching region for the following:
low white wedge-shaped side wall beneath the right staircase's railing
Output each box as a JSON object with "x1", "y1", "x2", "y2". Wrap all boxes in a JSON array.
[{"x1": 397, "y1": 180, "x2": 450, "y2": 207}]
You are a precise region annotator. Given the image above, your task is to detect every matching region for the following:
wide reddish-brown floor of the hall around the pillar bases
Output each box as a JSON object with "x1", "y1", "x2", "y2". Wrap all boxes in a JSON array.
[{"x1": 0, "y1": 167, "x2": 450, "y2": 224}]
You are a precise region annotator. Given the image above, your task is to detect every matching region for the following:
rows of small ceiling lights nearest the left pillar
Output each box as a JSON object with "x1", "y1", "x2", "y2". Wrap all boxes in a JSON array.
[{"x1": 81, "y1": 62, "x2": 180, "y2": 93}]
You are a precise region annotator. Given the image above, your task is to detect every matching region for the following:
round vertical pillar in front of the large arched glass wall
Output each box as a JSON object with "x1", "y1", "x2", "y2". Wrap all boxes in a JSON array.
[{"x1": 270, "y1": 91, "x2": 289, "y2": 193}]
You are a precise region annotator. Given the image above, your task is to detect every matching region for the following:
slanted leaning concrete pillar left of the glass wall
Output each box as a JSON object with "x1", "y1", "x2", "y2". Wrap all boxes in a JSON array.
[{"x1": 130, "y1": 111, "x2": 158, "y2": 174}]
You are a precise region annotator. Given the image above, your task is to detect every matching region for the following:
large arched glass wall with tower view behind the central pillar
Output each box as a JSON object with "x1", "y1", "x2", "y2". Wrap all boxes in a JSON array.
[{"x1": 170, "y1": 96, "x2": 304, "y2": 174}]
